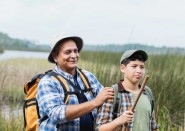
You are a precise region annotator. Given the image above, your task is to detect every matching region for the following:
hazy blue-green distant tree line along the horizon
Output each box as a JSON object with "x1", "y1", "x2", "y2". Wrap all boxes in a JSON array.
[{"x1": 0, "y1": 32, "x2": 185, "y2": 55}]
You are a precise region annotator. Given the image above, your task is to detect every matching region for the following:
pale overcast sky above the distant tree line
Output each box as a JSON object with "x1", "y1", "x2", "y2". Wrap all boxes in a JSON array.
[{"x1": 0, "y1": 0, "x2": 185, "y2": 48}]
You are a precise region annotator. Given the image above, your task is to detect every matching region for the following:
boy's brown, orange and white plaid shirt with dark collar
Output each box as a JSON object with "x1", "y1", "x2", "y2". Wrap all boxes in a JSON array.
[{"x1": 96, "y1": 81, "x2": 152, "y2": 131}]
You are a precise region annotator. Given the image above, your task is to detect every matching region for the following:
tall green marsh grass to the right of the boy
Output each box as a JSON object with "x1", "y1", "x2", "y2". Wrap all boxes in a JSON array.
[{"x1": 148, "y1": 54, "x2": 185, "y2": 127}]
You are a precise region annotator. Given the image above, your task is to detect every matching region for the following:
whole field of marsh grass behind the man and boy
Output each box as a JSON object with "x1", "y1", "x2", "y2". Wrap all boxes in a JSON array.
[{"x1": 0, "y1": 52, "x2": 185, "y2": 131}]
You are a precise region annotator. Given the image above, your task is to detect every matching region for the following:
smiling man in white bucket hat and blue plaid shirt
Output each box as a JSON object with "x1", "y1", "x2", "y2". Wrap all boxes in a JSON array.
[{"x1": 37, "y1": 33, "x2": 114, "y2": 131}]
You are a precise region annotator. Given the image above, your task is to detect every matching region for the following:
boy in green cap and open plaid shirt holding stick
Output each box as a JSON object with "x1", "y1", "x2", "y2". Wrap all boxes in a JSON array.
[{"x1": 96, "y1": 50, "x2": 157, "y2": 131}]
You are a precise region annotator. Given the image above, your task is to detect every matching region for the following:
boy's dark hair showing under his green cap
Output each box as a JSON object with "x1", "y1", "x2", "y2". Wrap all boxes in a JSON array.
[{"x1": 121, "y1": 53, "x2": 145, "y2": 66}]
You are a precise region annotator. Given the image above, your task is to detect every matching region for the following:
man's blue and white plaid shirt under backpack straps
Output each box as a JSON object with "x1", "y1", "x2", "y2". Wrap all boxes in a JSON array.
[{"x1": 36, "y1": 66, "x2": 103, "y2": 131}]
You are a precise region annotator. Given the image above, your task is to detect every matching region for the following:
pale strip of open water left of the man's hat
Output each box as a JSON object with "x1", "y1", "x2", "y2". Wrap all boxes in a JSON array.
[{"x1": 0, "y1": 50, "x2": 49, "y2": 60}]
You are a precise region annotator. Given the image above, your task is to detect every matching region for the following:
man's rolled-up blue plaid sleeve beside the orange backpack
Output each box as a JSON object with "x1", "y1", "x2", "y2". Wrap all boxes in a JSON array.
[{"x1": 37, "y1": 76, "x2": 66, "y2": 123}]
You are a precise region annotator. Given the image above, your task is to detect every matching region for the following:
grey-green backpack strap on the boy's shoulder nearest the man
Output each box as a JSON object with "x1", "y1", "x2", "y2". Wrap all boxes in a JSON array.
[{"x1": 112, "y1": 84, "x2": 121, "y2": 120}]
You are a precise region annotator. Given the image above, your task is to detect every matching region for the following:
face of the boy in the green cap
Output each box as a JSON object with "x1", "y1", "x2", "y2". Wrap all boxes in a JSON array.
[{"x1": 120, "y1": 60, "x2": 145, "y2": 84}]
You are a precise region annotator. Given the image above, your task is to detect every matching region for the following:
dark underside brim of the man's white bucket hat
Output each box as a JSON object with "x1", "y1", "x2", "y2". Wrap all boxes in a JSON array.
[{"x1": 48, "y1": 36, "x2": 83, "y2": 63}]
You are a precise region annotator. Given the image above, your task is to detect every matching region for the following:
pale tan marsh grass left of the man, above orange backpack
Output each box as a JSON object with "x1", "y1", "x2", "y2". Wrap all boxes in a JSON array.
[{"x1": 0, "y1": 59, "x2": 53, "y2": 103}]
